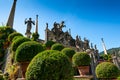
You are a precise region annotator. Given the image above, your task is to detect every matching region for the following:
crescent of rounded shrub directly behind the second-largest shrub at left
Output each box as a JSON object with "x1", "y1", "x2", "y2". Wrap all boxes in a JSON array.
[{"x1": 11, "y1": 36, "x2": 30, "y2": 52}]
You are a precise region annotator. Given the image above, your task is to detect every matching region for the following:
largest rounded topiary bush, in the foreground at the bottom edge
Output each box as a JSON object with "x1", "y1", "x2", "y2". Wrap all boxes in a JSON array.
[{"x1": 26, "y1": 50, "x2": 73, "y2": 80}]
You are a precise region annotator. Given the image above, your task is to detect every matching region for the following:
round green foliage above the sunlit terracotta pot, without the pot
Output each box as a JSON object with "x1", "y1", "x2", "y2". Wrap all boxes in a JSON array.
[{"x1": 72, "y1": 52, "x2": 91, "y2": 67}]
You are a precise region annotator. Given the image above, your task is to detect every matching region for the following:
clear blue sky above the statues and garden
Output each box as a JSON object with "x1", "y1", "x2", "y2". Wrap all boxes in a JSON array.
[{"x1": 0, "y1": 0, "x2": 120, "y2": 51}]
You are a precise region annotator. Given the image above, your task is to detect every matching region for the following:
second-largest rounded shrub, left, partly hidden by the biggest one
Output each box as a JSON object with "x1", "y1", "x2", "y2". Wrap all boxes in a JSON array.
[{"x1": 15, "y1": 41, "x2": 44, "y2": 62}]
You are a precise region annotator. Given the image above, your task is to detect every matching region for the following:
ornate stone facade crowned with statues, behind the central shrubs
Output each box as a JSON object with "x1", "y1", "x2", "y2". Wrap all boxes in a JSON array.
[{"x1": 45, "y1": 21, "x2": 95, "y2": 51}]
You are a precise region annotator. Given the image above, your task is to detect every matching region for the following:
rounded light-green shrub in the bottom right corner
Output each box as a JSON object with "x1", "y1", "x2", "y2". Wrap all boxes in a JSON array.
[{"x1": 95, "y1": 62, "x2": 119, "y2": 78}]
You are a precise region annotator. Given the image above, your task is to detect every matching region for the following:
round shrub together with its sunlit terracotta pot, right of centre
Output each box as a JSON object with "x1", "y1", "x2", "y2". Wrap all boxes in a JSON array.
[{"x1": 72, "y1": 52, "x2": 91, "y2": 76}]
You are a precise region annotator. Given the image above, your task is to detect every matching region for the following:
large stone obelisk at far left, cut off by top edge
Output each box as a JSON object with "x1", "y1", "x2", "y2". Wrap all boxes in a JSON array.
[{"x1": 6, "y1": 0, "x2": 17, "y2": 28}]
